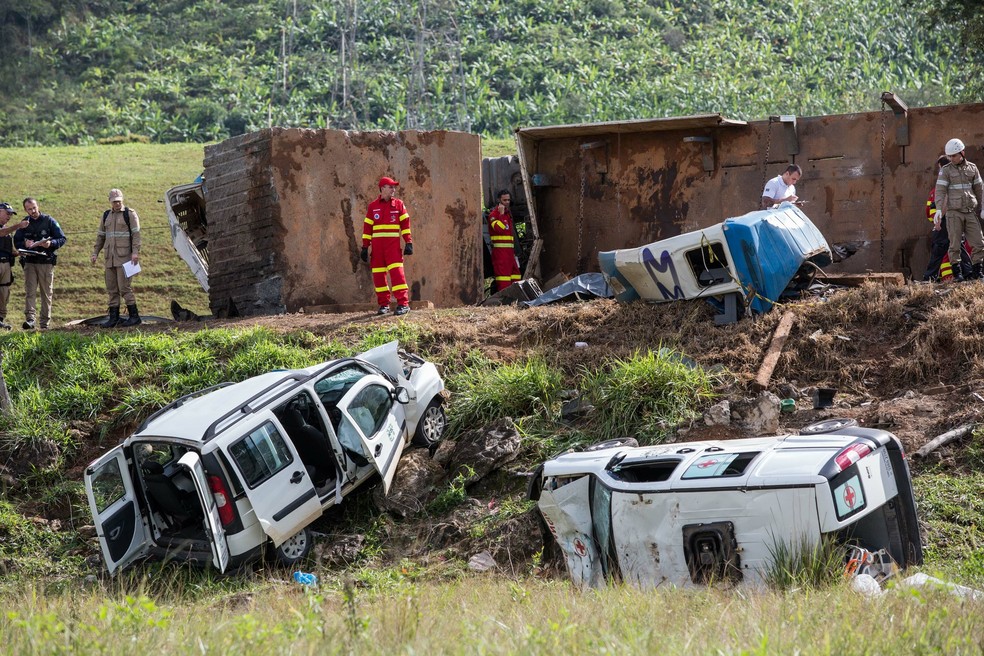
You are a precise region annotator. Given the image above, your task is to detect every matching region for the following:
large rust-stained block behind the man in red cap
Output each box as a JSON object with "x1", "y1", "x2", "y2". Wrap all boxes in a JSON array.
[{"x1": 206, "y1": 128, "x2": 482, "y2": 314}]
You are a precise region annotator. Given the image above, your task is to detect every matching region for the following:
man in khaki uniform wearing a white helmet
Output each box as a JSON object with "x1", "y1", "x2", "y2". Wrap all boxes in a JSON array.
[{"x1": 936, "y1": 139, "x2": 984, "y2": 282}]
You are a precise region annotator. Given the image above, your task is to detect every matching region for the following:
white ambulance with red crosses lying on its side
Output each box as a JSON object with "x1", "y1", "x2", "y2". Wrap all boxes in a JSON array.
[{"x1": 530, "y1": 421, "x2": 923, "y2": 588}]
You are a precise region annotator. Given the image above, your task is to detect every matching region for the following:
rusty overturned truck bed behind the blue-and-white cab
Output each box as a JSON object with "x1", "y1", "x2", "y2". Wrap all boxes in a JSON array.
[{"x1": 517, "y1": 104, "x2": 984, "y2": 279}]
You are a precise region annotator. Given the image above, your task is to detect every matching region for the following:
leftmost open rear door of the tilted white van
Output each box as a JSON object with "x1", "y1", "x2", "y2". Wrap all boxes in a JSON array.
[{"x1": 85, "y1": 446, "x2": 149, "y2": 574}]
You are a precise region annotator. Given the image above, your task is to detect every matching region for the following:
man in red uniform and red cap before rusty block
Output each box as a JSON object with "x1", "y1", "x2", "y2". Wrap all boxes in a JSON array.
[{"x1": 361, "y1": 178, "x2": 413, "y2": 315}]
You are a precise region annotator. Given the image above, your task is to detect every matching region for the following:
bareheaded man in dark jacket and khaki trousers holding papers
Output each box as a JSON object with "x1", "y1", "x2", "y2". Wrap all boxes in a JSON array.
[{"x1": 14, "y1": 196, "x2": 68, "y2": 330}]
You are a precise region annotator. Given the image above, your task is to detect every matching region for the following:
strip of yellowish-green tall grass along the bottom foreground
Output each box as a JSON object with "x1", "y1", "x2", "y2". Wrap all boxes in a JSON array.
[{"x1": 0, "y1": 580, "x2": 984, "y2": 656}]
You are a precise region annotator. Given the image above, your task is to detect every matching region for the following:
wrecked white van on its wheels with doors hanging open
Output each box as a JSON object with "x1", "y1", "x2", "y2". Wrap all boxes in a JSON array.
[{"x1": 85, "y1": 342, "x2": 447, "y2": 573}]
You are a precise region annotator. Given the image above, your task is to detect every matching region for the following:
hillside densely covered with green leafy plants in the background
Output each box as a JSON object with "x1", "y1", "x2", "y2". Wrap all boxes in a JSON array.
[{"x1": 0, "y1": 0, "x2": 981, "y2": 146}]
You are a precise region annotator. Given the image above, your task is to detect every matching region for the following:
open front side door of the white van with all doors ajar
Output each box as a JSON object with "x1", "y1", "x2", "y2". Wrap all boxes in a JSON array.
[{"x1": 338, "y1": 376, "x2": 407, "y2": 494}]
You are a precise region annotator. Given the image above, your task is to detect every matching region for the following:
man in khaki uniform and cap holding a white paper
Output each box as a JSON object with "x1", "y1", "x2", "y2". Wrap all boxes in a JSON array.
[{"x1": 90, "y1": 189, "x2": 140, "y2": 328}]
